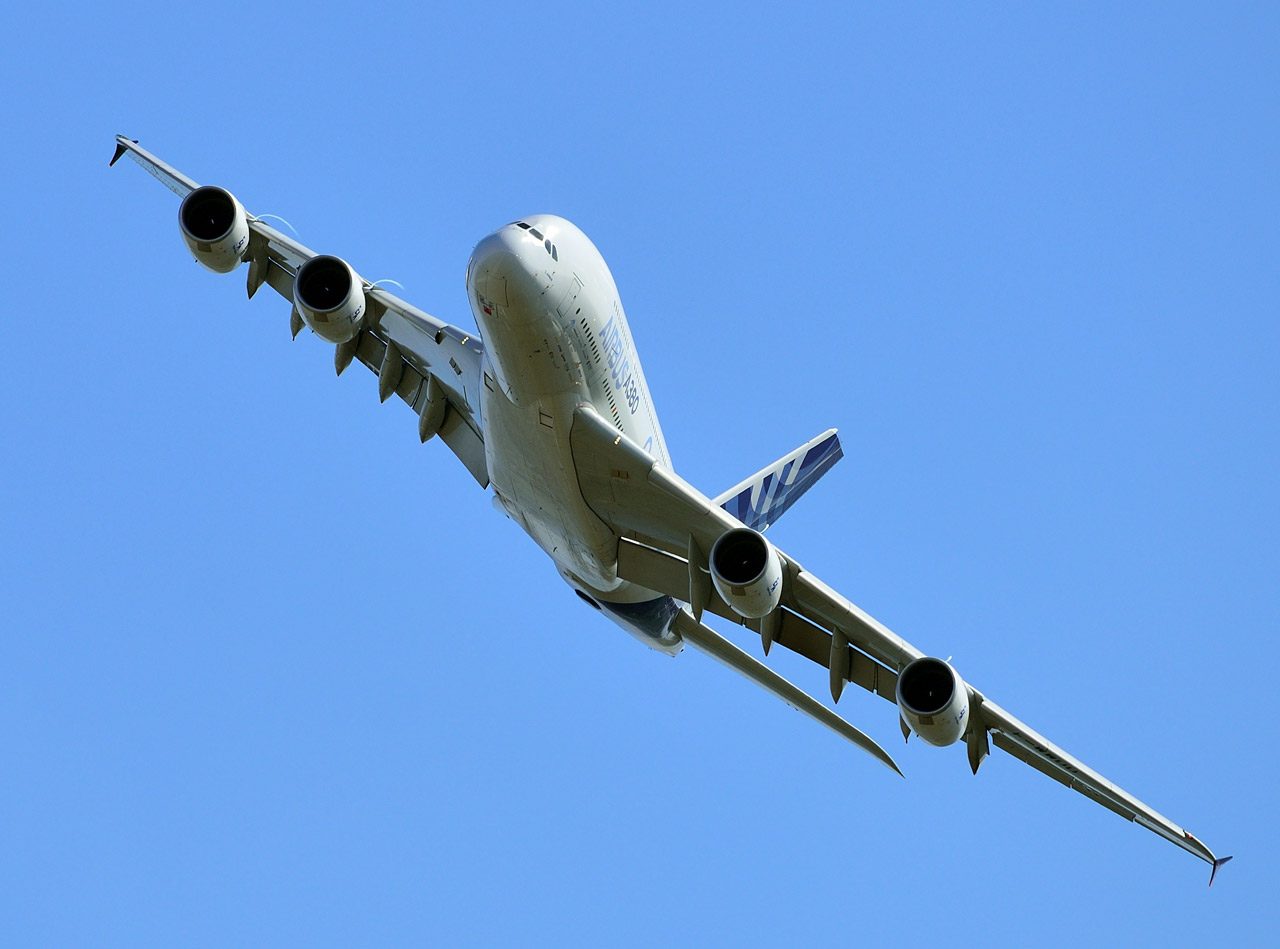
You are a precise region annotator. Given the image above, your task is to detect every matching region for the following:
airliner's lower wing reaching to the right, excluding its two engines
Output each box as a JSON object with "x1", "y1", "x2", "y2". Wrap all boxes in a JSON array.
[{"x1": 570, "y1": 407, "x2": 1230, "y2": 882}]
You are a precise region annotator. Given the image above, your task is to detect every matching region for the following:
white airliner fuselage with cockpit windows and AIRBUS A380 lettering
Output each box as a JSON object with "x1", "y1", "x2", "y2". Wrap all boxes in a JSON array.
[{"x1": 467, "y1": 214, "x2": 680, "y2": 652}]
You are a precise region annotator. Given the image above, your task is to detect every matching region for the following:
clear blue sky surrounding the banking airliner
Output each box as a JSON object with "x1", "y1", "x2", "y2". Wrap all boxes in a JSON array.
[{"x1": 0, "y1": 3, "x2": 1280, "y2": 946}]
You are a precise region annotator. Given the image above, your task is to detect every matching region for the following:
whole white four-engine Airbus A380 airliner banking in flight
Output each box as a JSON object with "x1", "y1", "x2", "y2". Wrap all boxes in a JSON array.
[{"x1": 111, "y1": 136, "x2": 1230, "y2": 885}]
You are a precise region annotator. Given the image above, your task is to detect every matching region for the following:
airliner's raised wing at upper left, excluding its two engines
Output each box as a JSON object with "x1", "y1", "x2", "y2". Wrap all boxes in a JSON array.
[{"x1": 111, "y1": 136, "x2": 489, "y2": 487}]
